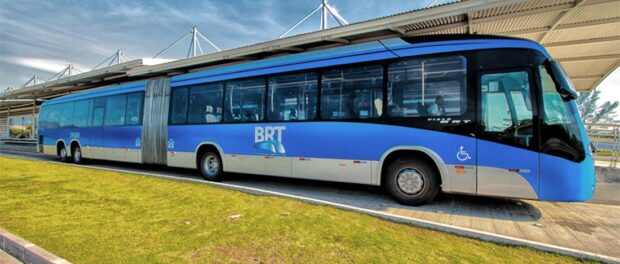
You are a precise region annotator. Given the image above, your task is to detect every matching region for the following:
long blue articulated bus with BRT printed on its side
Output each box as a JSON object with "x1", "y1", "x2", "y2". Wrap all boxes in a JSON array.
[{"x1": 38, "y1": 36, "x2": 595, "y2": 205}]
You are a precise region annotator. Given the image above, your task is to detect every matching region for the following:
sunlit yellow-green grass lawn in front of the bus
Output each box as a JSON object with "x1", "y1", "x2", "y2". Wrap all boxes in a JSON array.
[{"x1": 0, "y1": 157, "x2": 596, "y2": 263}]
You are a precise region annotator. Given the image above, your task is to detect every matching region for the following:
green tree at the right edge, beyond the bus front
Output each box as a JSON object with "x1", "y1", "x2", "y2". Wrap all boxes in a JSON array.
[{"x1": 577, "y1": 89, "x2": 618, "y2": 123}]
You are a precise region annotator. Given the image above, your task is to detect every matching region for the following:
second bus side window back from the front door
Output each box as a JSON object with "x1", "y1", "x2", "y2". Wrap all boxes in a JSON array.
[{"x1": 321, "y1": 65, "x2": 383, "y2": 119}]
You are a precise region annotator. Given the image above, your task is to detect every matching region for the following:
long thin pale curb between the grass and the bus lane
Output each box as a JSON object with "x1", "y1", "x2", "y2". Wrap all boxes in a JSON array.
[{"x1": 53, "y1": 161, "x2": 620, "y2": 264}]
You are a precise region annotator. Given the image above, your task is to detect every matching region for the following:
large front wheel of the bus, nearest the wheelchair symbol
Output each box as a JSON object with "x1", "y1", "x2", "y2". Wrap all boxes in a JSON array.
[{"x1": 383, "y1": 158, "x2": 439, "y2": 205}]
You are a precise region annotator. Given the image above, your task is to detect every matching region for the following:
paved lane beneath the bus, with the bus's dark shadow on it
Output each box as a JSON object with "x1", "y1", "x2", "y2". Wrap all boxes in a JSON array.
[{"x1": 0, "y1": 152, "x2": 620, "y2": 258}]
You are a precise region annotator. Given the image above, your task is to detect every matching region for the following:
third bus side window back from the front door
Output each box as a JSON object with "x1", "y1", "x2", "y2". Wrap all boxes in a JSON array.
[{"x1": 267, "y1": 73, "x2": 318, "y2": 121}]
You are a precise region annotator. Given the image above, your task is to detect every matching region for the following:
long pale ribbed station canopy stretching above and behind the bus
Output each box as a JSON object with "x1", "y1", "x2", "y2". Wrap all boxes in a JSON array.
[{"x1": 0, "y1": 0, "x2": 620, "y2": 106}]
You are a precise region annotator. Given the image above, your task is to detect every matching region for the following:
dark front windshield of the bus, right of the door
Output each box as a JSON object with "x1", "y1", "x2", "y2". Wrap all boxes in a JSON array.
[{"x1": 539, "y1": 63, "x2": 585, "y2": 162}]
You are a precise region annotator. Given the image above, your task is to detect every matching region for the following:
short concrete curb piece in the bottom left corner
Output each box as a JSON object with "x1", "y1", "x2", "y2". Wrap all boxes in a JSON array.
[{"x1": 0, "y1": 228, "x2": 71, "y2": 264}]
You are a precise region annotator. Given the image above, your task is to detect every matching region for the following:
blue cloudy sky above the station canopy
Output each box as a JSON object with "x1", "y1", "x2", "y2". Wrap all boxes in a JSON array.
[{"x1": 0, "y1": 0, "x2": 620, "y2": 107}]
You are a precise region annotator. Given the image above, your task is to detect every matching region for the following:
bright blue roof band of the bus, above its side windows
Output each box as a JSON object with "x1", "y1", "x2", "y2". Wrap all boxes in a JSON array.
[{"x1": 46, "y1": 35, "x2": 549, "y2": 104}]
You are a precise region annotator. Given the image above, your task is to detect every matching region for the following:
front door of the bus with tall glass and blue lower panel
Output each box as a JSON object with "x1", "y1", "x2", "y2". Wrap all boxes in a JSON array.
[{"x1": 476, "y1": 68, "x2": 539, "y2": 198}]
